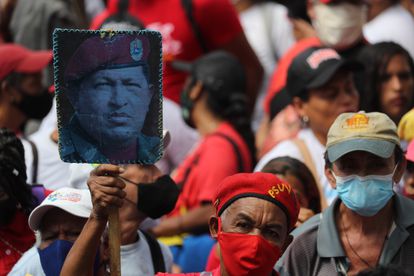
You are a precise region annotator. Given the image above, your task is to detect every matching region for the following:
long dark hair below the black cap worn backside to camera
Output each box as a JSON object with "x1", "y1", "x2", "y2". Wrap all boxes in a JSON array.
[{"x1": 200, "y1": 76, "x2": 256, "y2": 165}]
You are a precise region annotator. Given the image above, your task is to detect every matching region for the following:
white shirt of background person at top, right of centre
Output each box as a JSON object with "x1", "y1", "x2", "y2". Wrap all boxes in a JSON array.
[{"x1": 239, "y1": 2, "x2": 295, "y2": 130}]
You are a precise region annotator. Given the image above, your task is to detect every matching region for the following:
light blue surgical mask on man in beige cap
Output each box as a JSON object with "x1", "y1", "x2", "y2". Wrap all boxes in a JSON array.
[{"x1": 332, "y1": 166, "x2": 397, "y2": 217}]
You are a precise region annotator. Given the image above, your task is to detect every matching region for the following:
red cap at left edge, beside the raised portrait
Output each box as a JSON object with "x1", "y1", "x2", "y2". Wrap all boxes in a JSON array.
[{"x1": 0, "y1": 44, "x2": 52, "y2": 80}]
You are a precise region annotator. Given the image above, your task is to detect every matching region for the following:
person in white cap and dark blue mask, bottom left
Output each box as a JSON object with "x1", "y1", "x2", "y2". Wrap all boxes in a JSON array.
[{"x1": 9, "y1": 188, "x2": 92, "y2": 276}]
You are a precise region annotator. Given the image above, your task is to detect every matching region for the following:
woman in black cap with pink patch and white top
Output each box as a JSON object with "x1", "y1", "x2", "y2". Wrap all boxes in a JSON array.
[{"x1": 255, "y1": 47, "x2": 359, "y2": 208}]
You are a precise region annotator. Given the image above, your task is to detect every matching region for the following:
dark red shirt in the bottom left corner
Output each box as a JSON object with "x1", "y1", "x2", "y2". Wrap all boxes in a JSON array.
[{"x1": 0, "y1": 211, "x2": 35, "y2": 276}]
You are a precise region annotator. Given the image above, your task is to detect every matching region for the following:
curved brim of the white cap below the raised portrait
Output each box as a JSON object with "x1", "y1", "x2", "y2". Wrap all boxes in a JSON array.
[{"x1": 28, "y1": 201, "x2": 90, "y2": 231}]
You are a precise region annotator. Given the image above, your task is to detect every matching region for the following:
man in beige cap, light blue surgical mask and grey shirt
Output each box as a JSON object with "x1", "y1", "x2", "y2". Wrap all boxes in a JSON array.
[{"x1": 279, "y1": 111, "x2": 414, "y2": 275}]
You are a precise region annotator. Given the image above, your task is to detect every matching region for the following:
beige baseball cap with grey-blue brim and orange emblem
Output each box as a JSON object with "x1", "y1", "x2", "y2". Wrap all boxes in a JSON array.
[{"x1": 326, "y1": 111, "x2": 401, "y2": 162}]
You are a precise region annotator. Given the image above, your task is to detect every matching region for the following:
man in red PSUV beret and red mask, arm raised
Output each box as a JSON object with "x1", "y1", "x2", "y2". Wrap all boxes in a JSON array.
[{"x1": 61, "y1": 169, "x2": 299, "y2": 276}]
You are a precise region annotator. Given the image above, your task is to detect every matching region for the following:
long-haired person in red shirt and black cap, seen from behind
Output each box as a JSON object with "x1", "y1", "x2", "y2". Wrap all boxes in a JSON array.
[{"x1": 152, "y1": 51, "x2": 255, "y2": 272}]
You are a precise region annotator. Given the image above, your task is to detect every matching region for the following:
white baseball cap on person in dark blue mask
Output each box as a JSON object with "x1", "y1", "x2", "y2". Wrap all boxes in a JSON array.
[{"x1": 29, "y1": 188, "x2": 92, "y2": 231}]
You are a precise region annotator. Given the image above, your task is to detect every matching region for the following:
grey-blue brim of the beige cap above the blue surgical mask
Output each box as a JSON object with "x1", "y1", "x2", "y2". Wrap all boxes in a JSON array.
[{"x1": 327, "y1": 139, "x2": 396, "y2": 162}]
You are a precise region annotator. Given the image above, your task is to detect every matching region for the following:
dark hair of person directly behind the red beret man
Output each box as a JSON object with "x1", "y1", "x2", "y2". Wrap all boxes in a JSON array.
[{"x1": 261, "y1": 156, "x2": 321, "y2": 214}]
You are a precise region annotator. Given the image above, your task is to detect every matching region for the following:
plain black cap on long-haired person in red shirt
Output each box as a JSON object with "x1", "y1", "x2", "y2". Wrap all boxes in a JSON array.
[{"x1": 172, "y1": 51, "x2": 246, "y2": 92}]
